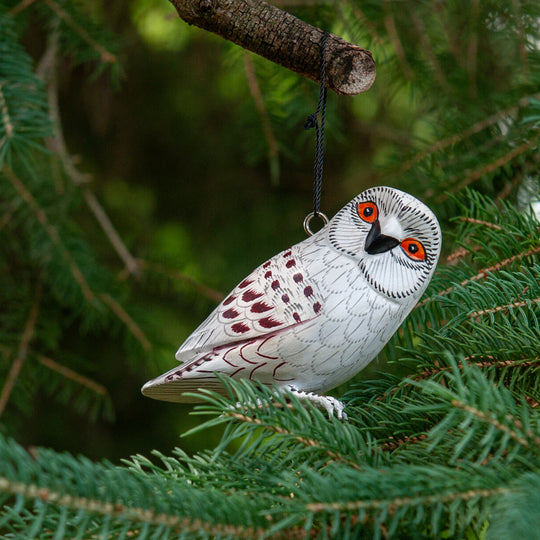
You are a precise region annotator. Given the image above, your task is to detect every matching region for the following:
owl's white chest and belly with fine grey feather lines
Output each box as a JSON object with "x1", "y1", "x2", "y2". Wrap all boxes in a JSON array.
[{"x1": 255, "y1": 237, "x2": 412, "y2": 391}]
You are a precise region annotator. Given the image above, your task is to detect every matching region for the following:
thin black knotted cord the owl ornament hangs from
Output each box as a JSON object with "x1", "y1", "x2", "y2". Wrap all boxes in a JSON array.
[{"x1": 304, "y1": 30, "x2": 328, "y2": 217}]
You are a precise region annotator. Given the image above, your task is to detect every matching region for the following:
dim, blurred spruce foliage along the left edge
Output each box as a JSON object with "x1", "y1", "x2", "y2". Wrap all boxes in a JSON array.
[{"x1": 0, "y1": 2, "x2": 147, "y2": 436}]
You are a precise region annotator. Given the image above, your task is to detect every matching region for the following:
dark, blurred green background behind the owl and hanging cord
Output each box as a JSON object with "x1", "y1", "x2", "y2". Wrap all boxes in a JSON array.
[{"x1": 3, "y1": 0, "x2": 538, "y2": 461}]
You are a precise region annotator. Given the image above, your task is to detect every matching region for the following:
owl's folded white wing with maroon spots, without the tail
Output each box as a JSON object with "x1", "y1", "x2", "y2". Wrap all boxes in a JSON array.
[{"x1": 176, "y1": 246, "x2": 322, "y2": 367}]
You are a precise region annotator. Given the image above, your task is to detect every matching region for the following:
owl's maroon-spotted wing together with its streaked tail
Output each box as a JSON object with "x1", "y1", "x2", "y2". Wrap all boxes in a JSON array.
[{"x1": 142, "y1": 244, "x2": 322, "y2": 402}]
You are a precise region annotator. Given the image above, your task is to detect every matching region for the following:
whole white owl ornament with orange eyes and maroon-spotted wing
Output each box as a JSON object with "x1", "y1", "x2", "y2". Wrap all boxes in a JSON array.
[{"x1": 142, "y1": 187, "x2": 441, "y2": 418}]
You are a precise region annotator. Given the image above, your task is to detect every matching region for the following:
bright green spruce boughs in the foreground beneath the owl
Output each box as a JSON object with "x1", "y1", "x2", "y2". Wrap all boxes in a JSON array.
[{"x1": 0, "y1": 357, "x2": 540, "y2": 538}]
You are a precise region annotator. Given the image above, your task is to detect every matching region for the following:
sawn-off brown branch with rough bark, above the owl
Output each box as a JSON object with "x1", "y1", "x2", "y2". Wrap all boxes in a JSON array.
[{"x1": 170, "y1": 0, "x2": 375, "y2": 95}]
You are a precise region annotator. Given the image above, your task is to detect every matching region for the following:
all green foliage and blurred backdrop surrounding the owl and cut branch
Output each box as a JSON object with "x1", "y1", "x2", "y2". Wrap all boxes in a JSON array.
[{"x1": 0, "y1": 0, "x2": 540, "y2": 539}]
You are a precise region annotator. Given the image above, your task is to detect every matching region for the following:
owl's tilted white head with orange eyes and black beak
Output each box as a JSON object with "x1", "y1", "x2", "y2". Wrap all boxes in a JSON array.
[{"x1": 321, "y1": 186, "x2": 441, "y2": 300}]
